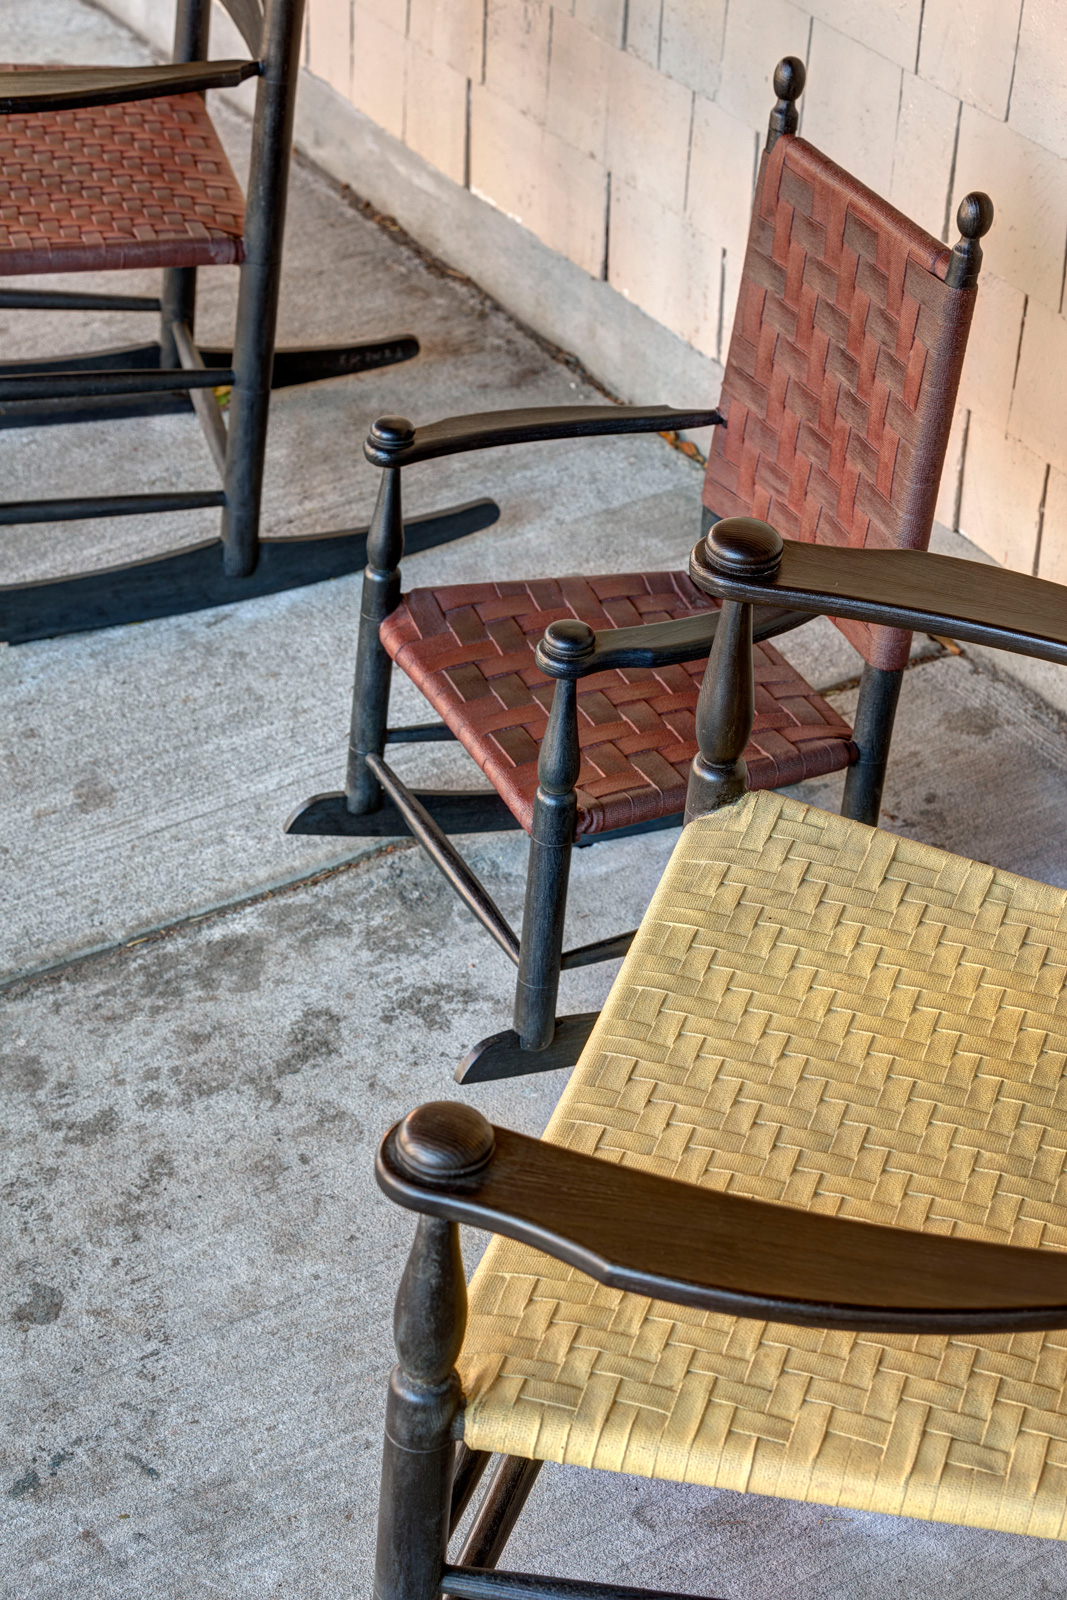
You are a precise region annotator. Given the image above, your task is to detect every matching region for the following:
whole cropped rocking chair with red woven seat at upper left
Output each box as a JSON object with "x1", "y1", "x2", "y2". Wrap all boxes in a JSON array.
[{"x1": 0, "y1": 0, "x2": 499, "y2": 643}]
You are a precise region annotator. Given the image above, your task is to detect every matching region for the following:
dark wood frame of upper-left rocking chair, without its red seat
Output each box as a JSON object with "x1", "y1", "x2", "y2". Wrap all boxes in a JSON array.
[{"x1": 0, "y1": 0, "x2": 499, "y2": 643}]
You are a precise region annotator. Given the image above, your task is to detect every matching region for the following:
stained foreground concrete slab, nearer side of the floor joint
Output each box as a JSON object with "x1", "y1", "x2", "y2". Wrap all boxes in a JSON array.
[{"x1": 0, "y1": 643, "x2": 1064, "y2": 1600}]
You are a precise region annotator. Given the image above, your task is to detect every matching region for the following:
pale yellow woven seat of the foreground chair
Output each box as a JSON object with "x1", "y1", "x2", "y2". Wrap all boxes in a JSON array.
[{"x1": 459, "y1": 794, "x2": 1067, "y2": 1538}]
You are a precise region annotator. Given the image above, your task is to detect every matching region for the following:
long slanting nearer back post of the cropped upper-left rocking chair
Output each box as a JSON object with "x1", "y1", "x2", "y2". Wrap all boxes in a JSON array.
[{"x1": 222, "y1": 0, "x2": 304, "y2": 578}]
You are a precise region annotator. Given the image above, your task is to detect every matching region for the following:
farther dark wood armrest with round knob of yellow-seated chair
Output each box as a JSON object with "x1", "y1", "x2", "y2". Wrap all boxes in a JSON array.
[{"x1": 689, "y1": 517, "x2": 1067, "y2": 664}]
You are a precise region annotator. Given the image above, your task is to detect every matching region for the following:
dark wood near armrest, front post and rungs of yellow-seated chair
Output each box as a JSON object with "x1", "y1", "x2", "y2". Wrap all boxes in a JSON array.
[{"x1": 374, "y1": 1088, "x2": 1067, "y2": 1600}]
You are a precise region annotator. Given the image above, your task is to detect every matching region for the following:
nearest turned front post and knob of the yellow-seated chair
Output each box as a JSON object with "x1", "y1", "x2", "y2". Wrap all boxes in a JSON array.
[{"x1": 374, "y1": 1101, "x2": 494, "y2": 1600}]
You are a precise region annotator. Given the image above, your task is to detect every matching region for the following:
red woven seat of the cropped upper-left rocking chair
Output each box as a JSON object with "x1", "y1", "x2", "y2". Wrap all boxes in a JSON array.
[{"x1": 0, "y1": 67, "x2": 245, "y2": 275}]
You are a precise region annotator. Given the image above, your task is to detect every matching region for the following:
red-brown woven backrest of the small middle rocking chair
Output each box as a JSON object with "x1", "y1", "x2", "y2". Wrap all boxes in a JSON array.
[{"x1": 704, "y1": 138, "x2": 976, "y2": 667}]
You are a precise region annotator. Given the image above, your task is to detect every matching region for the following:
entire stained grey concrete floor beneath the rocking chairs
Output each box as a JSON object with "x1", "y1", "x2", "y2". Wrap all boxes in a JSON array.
[{"x1": 0, "y1": 0, "x2": 1067, "y2": 1600}]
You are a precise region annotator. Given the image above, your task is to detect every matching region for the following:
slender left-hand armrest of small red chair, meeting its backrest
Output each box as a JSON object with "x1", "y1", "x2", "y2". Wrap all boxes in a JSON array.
[{"x1": 363, "y1": 405, "x2": 723, "y2": 467}]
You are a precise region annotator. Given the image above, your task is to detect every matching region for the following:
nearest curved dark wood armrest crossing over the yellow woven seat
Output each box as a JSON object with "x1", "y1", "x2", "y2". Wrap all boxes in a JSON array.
[{"x1": 376, "y1": 1101, "x2": 1067, "y2": 1333}]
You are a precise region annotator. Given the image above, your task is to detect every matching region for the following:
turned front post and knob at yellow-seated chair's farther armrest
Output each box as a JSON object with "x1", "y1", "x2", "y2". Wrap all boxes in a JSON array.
[{"x1": 685, "y1": 517, "x2": 782, "y2": 824}]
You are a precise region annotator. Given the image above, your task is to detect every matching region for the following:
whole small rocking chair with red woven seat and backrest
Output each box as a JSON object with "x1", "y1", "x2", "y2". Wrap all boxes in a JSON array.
[{"x1": 290, "y1": 58, "x2": 992, "y2": 1082}]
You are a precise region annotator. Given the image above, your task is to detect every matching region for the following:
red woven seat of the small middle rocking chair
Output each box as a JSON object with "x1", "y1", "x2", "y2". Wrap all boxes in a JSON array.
[{"x1": 381, "y1": 573, "x2": 854, "y2": 837}]
